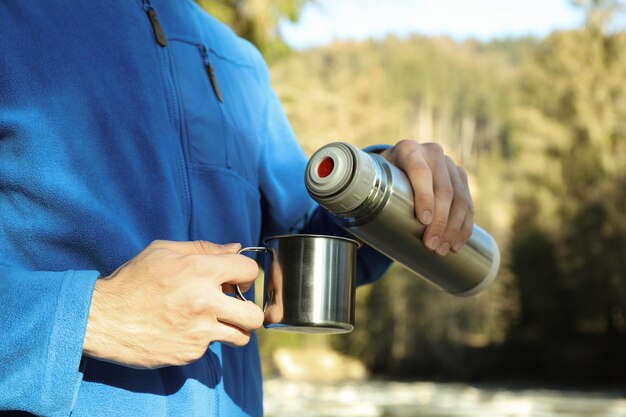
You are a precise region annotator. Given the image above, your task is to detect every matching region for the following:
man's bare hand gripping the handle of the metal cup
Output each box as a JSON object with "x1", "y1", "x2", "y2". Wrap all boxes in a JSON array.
[{"x1": 83, "y1": 241, "x2": 263, "y2": 368}]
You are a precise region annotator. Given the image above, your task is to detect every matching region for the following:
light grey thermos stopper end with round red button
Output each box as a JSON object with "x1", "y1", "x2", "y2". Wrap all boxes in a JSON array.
[{"x1": 305, "y1": 142, "x2": 376, "y2": 214}]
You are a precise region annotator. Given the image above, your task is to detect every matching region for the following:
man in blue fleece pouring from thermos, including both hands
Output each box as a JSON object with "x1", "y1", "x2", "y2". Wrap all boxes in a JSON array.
[{"x1": 0, "y1": 0, "x2": 473, "y2": 416}]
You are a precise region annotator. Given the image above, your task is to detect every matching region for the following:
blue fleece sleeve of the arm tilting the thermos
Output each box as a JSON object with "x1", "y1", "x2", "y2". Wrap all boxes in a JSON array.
[{"x1": 252, "y1": 56, "x2": 391, "y2": 284}]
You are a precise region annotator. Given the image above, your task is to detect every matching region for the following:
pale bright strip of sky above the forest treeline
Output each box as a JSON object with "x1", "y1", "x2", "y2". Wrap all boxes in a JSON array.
[{"x1": 280, "y1": 0, "x2": 583, "y2": 49}]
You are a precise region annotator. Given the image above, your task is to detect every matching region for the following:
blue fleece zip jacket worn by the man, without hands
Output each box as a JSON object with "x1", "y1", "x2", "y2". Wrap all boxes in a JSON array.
[{"x1": 0, "y1": 0, "x2": 389, "y2": 417}]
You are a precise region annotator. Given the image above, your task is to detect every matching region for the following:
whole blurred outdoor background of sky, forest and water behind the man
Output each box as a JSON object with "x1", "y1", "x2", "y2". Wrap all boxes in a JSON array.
[{"x1": 198, "y1": 0, "x2": 626, "y2": 417}]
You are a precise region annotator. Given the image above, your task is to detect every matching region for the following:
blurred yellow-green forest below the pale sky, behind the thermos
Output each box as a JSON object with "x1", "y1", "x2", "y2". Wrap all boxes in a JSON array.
[{"x1": 201, "y1": 0, "x2": 626, "y2": 386}]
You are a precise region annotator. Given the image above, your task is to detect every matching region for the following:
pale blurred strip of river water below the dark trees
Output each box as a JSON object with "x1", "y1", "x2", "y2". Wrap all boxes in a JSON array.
[{"x1": 264, "y1": 378, "x2": 626, "y2": 417}]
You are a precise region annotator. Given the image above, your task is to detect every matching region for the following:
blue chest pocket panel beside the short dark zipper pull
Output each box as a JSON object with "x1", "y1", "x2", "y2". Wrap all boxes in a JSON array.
[{"x1": 169, "y1": 40, "x2": 232, "y2": 167}]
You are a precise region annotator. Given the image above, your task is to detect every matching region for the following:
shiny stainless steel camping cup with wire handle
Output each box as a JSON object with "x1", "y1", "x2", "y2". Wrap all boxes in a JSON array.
[{"x1": 235, "y1": 235, "x2": 359, "y2": 333}]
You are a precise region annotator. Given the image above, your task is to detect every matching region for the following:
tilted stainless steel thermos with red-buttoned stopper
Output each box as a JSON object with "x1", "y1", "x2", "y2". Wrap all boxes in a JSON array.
[{"x1": 305, "y1": 142, "x2": 500, "y2": 296}]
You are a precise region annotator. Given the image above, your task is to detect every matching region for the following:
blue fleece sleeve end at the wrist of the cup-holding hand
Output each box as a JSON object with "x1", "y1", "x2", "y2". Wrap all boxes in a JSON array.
[{"x1": 0, "y1": 265, "x2": 99, "y2": 416}]
